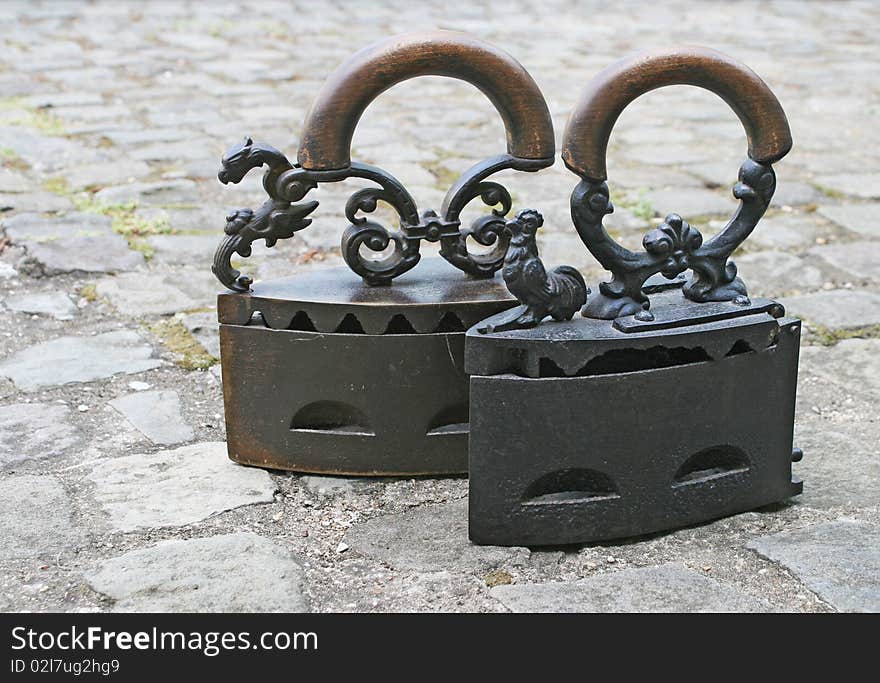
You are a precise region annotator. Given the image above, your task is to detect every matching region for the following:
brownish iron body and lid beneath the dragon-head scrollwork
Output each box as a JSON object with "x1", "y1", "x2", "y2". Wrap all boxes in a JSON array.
[{"x1": 218, "y1": 258, "x2": 516, "y2": 475}]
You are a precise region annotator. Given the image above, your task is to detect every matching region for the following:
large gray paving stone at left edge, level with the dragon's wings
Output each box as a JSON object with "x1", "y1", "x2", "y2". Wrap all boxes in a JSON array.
[{"x1": 3, "y1": 213, "x2": 144, "y2": 275}]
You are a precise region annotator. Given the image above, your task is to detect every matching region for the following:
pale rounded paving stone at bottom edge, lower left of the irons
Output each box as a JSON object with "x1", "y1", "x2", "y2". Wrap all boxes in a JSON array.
[{"x1": 86, "y1": 533, "x2": 308, "y2": 612}]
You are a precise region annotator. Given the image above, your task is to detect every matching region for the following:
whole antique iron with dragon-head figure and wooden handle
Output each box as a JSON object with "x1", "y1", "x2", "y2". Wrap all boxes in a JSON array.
[{"x1": 213, "y1": 31, "x2": 555, "y2": 474}]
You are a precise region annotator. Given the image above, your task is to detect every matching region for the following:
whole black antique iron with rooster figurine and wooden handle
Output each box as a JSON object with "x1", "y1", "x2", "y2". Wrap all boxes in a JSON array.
[{"x1": 465, "y1": 48, "x2": 802, "y2": 545}]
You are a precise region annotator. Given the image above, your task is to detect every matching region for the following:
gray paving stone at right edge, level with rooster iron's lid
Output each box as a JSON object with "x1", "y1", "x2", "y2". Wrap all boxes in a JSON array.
[{"x1": 781, "y1": 289, "x2": 880, "y2": 330}]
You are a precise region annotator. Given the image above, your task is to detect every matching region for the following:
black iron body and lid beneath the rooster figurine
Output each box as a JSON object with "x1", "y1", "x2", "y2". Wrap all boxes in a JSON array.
[{"x1": 465, "y1": 283, "x2": 802, "y2": 545}]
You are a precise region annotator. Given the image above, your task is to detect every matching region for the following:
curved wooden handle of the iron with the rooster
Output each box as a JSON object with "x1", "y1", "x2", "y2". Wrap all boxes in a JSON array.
[{"x1": 562, "y1": 47, "x2": 791, "y2": 180}]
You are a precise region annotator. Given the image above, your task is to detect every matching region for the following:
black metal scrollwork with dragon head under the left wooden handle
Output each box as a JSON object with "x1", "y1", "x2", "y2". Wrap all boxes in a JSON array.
[{"x1": 212, "y1": 138, "x2": 548, "y2": 291}]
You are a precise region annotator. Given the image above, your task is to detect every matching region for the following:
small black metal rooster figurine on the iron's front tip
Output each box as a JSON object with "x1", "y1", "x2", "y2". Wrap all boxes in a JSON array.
[{"x1": 478, "y1": 209, "x2": 590, "y2": 334}]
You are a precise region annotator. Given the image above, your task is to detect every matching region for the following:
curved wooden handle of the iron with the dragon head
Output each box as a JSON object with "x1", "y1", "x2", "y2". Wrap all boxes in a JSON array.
[{"x1": 297, "y1": 31, "x2": 555, "y2": 171}]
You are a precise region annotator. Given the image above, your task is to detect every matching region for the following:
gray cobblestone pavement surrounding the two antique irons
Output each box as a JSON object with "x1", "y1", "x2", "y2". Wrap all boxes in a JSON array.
[{"x1": 0, "y1": 0, "x2": 880, "y2": 612}]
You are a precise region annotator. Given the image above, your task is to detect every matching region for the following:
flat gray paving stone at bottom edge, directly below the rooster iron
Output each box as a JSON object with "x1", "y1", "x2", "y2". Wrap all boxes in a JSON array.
[{"x1": 491, "y1": 564, "x2": 772, "y2": 612}]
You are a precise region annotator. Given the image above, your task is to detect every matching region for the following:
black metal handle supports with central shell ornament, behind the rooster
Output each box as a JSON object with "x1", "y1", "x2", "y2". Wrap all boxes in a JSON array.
[{"x1": 571, "y1": 159, "x2": 776, "y2": 320}]
